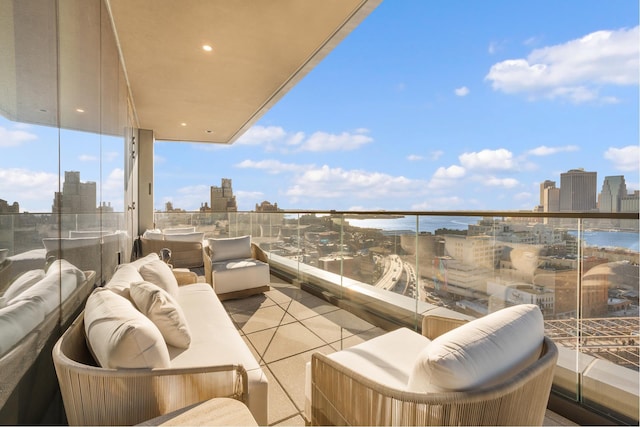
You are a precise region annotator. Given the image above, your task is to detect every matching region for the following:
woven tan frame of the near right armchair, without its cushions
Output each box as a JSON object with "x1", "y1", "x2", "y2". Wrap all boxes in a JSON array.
[{"x1": 310, "y1": 317, "x2": 558, "y2": 426}]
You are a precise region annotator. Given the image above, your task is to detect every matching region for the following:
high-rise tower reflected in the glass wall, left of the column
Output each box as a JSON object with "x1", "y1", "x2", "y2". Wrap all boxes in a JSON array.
[{"x1": 52, "y1": 171, "x2": 97, "y2": 214}]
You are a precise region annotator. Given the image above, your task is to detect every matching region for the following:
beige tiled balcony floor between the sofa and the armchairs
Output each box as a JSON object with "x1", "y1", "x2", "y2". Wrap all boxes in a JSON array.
[{"x1": 219, "y1": 276, "x2": 575, "y2": 426}]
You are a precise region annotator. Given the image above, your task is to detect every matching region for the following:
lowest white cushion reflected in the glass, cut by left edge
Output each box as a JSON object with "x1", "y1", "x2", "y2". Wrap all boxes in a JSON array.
[{"x1": 0, "y1": 297, "x2": 45, "y2": 357}]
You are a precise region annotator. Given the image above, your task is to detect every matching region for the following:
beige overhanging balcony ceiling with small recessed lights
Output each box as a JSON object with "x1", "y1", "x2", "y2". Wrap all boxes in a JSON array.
[{"x1": 106, "y1": 0, "x2": 381, "y2": 144}]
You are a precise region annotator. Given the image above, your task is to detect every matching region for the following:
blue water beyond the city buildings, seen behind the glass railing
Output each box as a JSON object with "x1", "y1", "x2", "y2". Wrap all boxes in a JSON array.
[{"x1": 348, "y1": 216, "x2": 640, "y2": 252}]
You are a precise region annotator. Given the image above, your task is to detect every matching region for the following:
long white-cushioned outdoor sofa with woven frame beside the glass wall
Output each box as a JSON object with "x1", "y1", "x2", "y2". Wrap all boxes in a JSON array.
[{"x1": 53, "y1": 253, "x2": 268, "y2": 425}]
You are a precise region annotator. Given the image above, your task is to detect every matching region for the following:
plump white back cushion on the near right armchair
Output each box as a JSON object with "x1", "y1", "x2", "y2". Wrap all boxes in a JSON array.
[{"x1": 408, "y1": 304, "x2": 544, "y2": 392}]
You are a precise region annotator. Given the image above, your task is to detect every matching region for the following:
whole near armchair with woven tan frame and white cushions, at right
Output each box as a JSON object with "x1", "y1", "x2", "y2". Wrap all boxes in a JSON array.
[{"x1": 307, "y1": 305, "x2": 558, "y2": 425}]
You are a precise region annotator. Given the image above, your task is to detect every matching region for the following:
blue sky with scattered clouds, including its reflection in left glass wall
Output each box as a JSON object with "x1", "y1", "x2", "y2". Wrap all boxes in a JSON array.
[{"x1": 0, "y1": 0, "x2": 640, "y2": 211}]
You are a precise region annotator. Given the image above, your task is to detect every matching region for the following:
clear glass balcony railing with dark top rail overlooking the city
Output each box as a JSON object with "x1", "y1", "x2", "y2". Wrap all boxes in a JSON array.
[{"x1": 156, "y1": 211, "x2": 640, "y2": 422}]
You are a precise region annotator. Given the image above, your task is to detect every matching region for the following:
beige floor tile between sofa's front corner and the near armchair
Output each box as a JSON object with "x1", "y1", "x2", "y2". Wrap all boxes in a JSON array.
[{"x1": 269, "y1": 346, "x2": 334, "y2": 411}]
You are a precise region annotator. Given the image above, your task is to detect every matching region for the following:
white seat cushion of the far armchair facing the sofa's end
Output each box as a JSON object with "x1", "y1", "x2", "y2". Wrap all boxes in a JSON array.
[{"x1": 211, "y1": 258, "x2": 271, "y2": 294}]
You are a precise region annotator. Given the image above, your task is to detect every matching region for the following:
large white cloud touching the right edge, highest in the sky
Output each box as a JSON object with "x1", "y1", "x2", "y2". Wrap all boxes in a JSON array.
[{"x1": 485, "y1": 27, "x2": 640, "y2": 103}]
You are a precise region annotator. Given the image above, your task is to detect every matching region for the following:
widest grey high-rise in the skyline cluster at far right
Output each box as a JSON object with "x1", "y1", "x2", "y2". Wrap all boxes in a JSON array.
[{"x1": 560, "y1": 168, "x2": 598, "y2": 212}]
